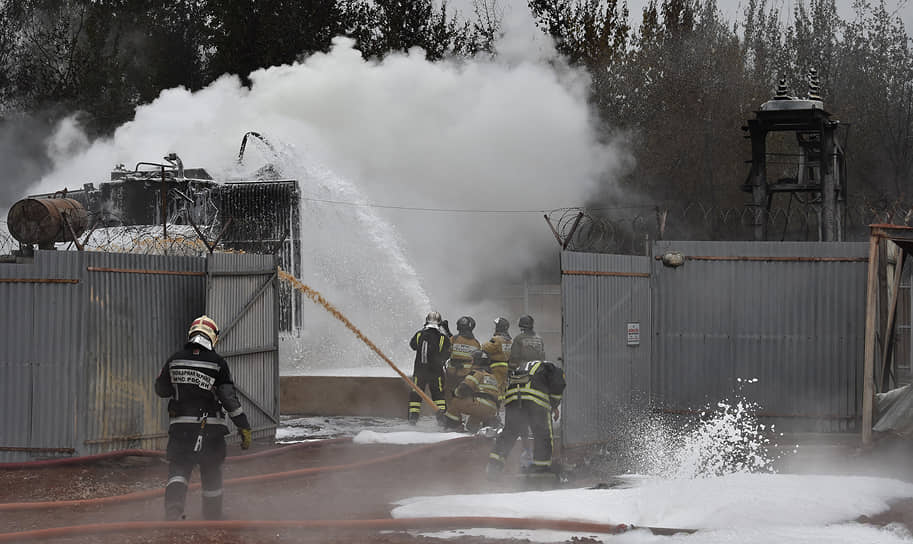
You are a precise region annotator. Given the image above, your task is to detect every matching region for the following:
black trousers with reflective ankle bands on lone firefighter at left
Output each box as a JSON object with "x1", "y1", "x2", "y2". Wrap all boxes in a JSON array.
[{"x1": 165, "y1": 425, "x2": 225, "y2": 521}]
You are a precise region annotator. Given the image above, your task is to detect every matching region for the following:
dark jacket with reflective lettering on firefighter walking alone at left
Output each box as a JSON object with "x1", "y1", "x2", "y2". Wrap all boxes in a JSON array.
[{"x1": 155, "y1": 343, "x2": 250, "y2": 434}]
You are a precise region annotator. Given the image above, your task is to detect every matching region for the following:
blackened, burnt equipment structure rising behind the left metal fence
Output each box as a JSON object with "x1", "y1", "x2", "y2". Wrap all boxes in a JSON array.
[{"x1": 20, "y1": 153, "x2": 301, "y2": 331}]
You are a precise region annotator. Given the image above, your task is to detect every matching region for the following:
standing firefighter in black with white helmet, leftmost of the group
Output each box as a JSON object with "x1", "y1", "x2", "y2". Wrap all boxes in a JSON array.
[{"x1": 409, "y1": 312, "x2": 450, "y2": 425}]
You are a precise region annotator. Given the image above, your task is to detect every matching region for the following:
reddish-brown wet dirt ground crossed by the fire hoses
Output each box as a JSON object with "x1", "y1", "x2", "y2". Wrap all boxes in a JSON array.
[{"x1": 0, "y1": 437, "x2": 913, "y2": 544}]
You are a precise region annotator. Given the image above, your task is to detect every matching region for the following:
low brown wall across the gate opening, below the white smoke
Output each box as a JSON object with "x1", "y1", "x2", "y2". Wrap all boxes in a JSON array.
[{"x1": 279, "y1": 376, "x2": 431, "y2": 418}]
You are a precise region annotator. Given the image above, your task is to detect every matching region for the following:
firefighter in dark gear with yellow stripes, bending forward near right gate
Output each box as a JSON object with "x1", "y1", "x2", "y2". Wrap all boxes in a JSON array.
[{"x1": 488, "y1": 361, "x2": 566, "y2": 474}]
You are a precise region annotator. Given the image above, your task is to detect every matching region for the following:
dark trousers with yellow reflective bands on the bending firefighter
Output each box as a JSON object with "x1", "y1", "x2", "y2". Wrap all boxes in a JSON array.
[{"x1": 490, "y1": 400, "x2": 553, "y2": 470}]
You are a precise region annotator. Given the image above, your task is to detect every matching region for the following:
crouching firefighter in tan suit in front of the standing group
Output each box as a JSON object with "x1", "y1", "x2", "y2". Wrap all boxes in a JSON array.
[{"x1": 441, "y1": 349, "x2": 501, "y2": 433}]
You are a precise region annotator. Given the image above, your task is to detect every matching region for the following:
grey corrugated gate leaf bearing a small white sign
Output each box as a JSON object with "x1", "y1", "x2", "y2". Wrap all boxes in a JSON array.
[{"x1": 561, "y1": 252, "x2": 652, "y2": 444}]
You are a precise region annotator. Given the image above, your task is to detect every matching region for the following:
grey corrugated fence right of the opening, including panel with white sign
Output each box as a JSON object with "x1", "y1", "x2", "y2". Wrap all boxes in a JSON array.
[{"x1": 562, "y1": 242, "x2": 867, "y2": 443}]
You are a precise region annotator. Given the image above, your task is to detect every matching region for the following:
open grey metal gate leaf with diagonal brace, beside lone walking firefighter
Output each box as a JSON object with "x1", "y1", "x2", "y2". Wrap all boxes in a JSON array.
[{"x1": 206, "y1": 254, "x2": 279, "y2": 438}]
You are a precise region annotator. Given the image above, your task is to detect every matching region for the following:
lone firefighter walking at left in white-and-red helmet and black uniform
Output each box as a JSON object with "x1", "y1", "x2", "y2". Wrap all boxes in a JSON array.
[{"x1": 155, "y1": 315, "x2": 252, "y2": 521}]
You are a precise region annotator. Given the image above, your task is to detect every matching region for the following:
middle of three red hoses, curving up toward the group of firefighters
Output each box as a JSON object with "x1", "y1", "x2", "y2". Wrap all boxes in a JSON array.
[{"x1": 0, "y1": 436, "x2": 475, "y2": 512}]
